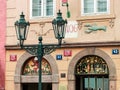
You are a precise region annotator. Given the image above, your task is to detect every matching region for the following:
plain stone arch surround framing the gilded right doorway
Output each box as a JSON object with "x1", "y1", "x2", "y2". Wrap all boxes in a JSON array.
[{"x1": 68, "y1": 48, "x2": 116, "y2": 90}]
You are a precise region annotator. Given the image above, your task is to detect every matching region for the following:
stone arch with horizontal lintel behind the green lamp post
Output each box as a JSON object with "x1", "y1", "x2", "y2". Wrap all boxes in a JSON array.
[{"x1": 14, "y1": 52, "x2": 59, "y2": 90}]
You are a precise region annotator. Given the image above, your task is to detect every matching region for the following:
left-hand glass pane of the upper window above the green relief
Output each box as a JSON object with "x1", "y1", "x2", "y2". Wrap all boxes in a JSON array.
[{"x1": 84, "y1": 0, "x2": 94, "y2": 13}]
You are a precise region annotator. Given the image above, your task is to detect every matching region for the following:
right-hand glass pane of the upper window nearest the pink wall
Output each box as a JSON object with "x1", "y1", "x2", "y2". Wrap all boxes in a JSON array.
[{"x1": 46, "y1": 0, "x2": 53, "y2": 16}]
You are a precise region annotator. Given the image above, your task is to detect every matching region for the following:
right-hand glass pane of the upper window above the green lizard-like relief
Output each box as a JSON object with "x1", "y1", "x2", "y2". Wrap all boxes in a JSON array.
[{"x1": 97, "y1": 0, "x2": 107, "y2": 12}]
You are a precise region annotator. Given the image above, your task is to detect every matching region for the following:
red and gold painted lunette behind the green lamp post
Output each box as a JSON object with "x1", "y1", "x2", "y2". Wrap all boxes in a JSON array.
[{"x1": 23, "y1": 58, "x2": 52, "y2": 75}]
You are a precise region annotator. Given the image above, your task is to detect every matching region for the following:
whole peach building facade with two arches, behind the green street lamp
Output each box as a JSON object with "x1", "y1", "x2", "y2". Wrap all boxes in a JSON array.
[{"x1": 5, "y1": 0, "x2": 120, "y2": 90}]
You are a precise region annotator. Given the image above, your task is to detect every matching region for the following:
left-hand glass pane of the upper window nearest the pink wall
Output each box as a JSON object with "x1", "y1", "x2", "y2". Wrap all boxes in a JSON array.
[{"x1": 32, "y1": 0, "x2": 41, "y2": 16}]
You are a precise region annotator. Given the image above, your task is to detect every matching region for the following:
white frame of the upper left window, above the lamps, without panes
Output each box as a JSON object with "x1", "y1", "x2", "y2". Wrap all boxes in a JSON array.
[{"x1": 30, "y1": 0, "x2": 56, "y2": 19}]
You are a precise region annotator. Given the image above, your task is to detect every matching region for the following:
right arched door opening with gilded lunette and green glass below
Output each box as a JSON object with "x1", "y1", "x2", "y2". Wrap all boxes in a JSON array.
[{"x1": 75, "y1": 55, "x2": 109, "y2": 90}]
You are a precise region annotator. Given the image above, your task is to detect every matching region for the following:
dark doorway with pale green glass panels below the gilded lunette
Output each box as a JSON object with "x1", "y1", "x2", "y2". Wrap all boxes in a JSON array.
[{"x1": 76, "y1": 75, "x2": 109, "y2": 90}]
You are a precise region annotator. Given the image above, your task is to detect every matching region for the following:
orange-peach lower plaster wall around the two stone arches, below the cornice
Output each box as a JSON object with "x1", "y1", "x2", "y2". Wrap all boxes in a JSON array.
[{"x1": 6, "y1": 47, "x2": 120, "y2": 90}]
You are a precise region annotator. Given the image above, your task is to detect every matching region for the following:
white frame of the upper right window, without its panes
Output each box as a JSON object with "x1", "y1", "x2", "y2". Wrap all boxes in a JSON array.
[{"x1": 81, "y1": 0, "x2": 110, "y2": 16}]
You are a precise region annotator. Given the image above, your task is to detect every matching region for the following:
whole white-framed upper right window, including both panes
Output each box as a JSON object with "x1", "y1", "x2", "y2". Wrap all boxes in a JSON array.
[{"x1": 81, "y1": 0, "x2": 109, "y2": 15}]
